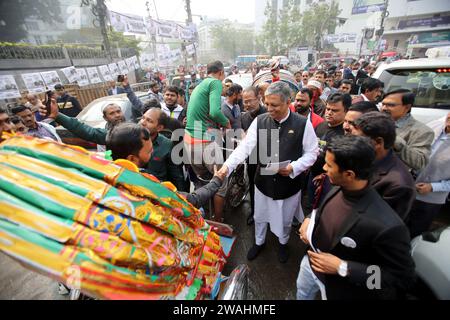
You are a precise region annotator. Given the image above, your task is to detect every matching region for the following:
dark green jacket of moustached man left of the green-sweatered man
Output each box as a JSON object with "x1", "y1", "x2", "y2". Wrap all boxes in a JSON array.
[{"x1": 147, "y1": 134, "x2": 184, "y2": 191}]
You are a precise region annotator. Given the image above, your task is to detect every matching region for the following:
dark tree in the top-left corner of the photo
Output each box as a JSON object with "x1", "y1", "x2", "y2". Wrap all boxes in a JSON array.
[{"x1": 0, "y1": 0, "x2": 63, "y2": 42}]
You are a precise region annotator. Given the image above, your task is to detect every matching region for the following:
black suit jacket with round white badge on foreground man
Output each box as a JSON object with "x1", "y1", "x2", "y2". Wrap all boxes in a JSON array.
[{"x1": 313, "y1": 187, "x2": 415, "y2": 300}]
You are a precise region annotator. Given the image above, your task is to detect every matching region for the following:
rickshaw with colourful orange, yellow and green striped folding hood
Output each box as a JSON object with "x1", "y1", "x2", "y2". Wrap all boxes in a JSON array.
[{"x1": 0, "y1": 135, "x2": 249, "y2": 300}]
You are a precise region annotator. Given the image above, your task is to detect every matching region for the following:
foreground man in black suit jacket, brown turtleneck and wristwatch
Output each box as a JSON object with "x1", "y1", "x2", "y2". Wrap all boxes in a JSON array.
[{"x1": 297, "y1": 136, "x2": 414, "y2": 300}]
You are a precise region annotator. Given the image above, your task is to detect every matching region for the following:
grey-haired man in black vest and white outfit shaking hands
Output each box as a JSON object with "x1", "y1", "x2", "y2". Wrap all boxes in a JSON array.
[{"x1": 221, "y1": 82, "x2": 318, "y2": 263}]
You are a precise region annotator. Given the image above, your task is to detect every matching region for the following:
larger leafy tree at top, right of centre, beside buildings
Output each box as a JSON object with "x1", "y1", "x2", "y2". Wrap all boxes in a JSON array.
[{"x1": 257, "y1": 0, "x2": 341, "y2": 55}]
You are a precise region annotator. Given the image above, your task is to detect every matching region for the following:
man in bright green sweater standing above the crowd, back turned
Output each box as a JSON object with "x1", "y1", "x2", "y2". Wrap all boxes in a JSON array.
[{"x1": 184, "y1": 61, "x2": 231, "y2": 221}]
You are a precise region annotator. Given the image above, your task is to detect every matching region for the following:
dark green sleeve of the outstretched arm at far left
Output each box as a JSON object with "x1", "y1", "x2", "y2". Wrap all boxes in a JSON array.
[{"x1": 55, "y1": 113, "x2": 107, "y2": 146}]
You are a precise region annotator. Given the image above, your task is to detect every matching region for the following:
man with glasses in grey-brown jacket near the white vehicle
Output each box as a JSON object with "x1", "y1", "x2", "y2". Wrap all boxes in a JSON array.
[{"x1": 381, "y1": 89, "x2": 434, "y2": 171}]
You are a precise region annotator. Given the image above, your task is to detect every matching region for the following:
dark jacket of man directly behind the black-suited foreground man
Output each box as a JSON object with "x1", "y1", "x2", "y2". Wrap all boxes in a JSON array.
[{"x1": 371, "y1": 151, "x2": 416, "y2": 221}]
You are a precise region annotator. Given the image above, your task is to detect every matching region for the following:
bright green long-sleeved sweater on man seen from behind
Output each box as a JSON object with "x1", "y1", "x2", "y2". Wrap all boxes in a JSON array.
[{"x1": 186, "y1": 78, "x2": 229, "y2": 140}]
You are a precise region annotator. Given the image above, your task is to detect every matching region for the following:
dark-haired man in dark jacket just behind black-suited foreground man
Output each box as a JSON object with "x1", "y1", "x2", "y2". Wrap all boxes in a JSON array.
[{"x1": 354, "y1": 112, "x2": 416, "y2": 221}]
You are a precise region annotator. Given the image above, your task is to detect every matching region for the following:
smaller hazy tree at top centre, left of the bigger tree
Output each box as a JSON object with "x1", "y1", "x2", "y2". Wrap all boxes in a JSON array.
[{"x1": 211, "y1": 21, "x2": 255, "y2": 61}]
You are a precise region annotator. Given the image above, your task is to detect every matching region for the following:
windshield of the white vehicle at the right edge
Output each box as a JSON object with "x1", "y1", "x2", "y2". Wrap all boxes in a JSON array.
[{"x1": 380, "y1": 69, "x2": 450, "y2": 109}]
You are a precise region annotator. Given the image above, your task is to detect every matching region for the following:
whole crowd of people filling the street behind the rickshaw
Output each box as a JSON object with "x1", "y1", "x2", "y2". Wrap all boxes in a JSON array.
[{"x1": 0, "y1": 57, "x2": 450, "y2": 300}]
